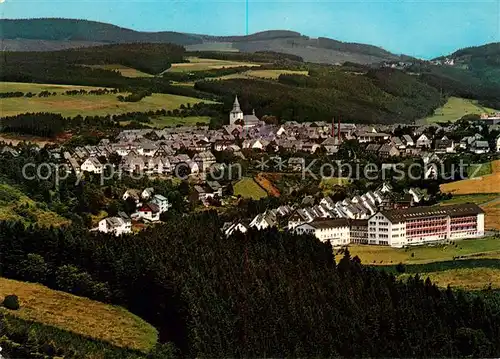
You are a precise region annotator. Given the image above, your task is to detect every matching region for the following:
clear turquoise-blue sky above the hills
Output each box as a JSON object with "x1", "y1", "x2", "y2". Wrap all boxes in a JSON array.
[{"x1": 0, "y1": 0, "x2": 500, "y2": 59}]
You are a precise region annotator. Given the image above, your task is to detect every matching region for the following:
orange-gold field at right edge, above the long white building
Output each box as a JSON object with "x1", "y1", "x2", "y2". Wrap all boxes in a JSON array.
[{"x1": 440, "y1": 160, "x2": 500, "y2": 195}]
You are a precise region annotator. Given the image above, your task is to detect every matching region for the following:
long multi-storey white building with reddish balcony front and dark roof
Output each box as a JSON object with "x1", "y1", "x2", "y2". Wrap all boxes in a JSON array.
[{"x1": 368, "y1": 203, "x2": 484, "y2": 247}]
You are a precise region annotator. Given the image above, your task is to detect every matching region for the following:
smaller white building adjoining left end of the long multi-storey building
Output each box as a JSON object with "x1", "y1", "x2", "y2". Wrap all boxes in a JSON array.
[{"x1": 294, "y1": 218, "x2": 350, "y2": 247}]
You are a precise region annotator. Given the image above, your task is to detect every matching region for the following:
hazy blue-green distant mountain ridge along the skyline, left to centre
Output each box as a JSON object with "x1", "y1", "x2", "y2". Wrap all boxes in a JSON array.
[{"x1": 0, "y1": 18, "x2": 408, "y2": 64}]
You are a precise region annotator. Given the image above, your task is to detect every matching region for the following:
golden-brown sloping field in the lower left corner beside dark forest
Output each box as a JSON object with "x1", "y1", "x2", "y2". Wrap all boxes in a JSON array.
[{"x1": 0, "y1": 278, "x2": 158, "y2": 351}]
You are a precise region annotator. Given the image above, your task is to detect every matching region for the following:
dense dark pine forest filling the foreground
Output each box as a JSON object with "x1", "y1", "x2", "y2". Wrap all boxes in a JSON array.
[{"x1": 0, "y1": 213, "x2": 500, "y2": 357}]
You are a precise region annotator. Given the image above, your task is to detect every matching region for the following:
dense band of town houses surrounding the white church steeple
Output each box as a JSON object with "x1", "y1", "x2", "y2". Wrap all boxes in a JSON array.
[{"x1": 59, "y1": 98, "x2": 500, "y2": 184}]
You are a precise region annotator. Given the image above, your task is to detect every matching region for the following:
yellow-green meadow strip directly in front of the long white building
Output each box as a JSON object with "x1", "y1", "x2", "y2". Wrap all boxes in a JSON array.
[{"x1": 349, "y1": 238, "x2": 500, "y2": 265}]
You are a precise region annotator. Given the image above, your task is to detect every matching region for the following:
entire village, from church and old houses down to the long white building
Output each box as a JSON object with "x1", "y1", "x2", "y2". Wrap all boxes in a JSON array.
[{"x1": 2, "y1": 97, "x2": 500, "y2": 247}]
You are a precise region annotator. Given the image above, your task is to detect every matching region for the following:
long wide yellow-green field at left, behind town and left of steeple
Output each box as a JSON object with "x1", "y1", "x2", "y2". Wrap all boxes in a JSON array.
[{"x1": 0, "y1": 85, "x2": 209, "y2": 116}]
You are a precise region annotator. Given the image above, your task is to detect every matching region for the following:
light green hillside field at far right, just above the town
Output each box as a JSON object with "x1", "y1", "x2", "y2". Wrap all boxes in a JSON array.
[{"x1": 425, "y1": 97, "x2": 497, "y2": 123}]
